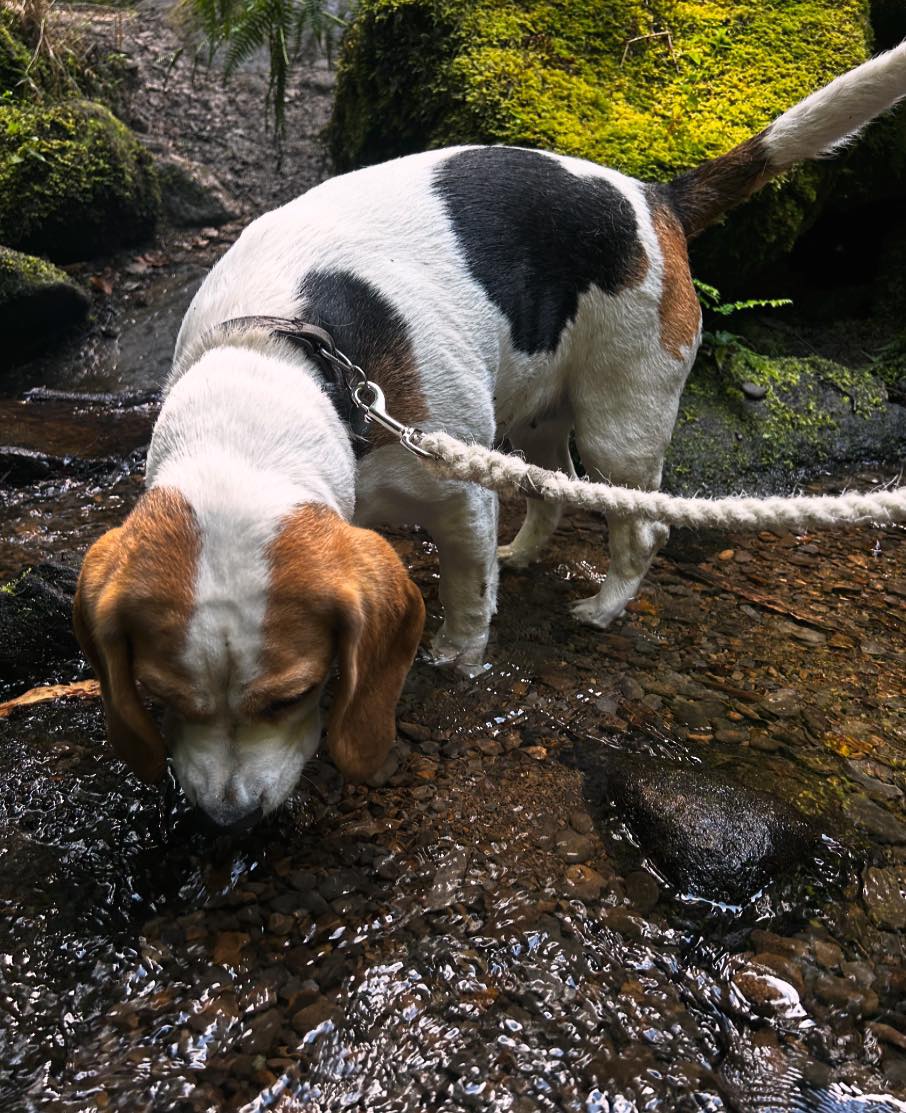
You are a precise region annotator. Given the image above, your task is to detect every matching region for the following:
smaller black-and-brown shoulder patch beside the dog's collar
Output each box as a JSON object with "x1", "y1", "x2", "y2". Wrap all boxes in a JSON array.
[{"x1": 298, "y1": 270, "x2": 429, "y2": 444}]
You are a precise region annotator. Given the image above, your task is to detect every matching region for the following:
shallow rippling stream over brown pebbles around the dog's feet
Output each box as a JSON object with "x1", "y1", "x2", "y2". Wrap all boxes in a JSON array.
[{"x1": 0, "y1": 279, "x2": 906, "y2": 1113}]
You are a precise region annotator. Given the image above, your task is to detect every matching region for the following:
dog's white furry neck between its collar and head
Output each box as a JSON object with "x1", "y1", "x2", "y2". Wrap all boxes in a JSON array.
[{"x1": 146, "y1": 339, "x2": 355, "y2": 520}]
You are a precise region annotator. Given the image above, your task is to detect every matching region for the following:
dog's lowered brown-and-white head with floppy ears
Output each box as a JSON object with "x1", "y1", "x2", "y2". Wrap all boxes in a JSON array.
[{"x1": 75, "y1": 487, "x2": 424, "y2": 826}]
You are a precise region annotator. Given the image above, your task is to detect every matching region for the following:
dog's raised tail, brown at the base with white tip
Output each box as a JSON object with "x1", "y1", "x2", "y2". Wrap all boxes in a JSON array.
[{"x1": 668, "y1": 42, "x2": 906, "y2": 239}]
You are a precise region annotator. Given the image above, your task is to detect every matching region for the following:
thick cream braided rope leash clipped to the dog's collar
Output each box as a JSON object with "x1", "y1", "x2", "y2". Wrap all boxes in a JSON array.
[{"x1": 418, "y1": 433, "x2": 906, "y2": 530}]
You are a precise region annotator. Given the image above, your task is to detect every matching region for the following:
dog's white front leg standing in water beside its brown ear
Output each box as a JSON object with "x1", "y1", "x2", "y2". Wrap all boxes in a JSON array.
[{"x1": 426, "y1": 486, "x2": 498, "y2": 676}]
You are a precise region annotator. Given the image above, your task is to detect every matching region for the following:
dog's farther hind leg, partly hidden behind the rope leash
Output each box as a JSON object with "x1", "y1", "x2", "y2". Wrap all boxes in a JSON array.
[{"x1": 498, "y1": 413, "x2": 575, "y2": 568}]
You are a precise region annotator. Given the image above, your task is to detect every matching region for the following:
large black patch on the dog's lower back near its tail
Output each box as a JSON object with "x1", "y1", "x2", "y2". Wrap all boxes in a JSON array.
[{"x1": 434, "y1": 147, "x2": 647, "y2": 353}]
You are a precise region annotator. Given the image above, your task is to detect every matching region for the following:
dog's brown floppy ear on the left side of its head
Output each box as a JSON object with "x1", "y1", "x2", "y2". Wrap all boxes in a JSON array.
[{"x1": 72, "y1": 528, "x2": 166, "y2": 781}]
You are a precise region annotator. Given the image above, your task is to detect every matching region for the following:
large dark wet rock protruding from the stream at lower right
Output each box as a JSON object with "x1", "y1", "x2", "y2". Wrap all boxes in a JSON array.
[{"x1": 607, "y1": 760, "x2": 814, "y2": 900}]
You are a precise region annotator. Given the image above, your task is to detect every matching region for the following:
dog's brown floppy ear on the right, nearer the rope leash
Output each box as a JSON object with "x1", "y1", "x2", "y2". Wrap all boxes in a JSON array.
[{"x1": 327, "y1": 528, "x2": 425, "y2": 780}]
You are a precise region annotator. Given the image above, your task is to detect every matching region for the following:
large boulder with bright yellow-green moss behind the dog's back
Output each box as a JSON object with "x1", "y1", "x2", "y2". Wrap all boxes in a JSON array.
[{"x1": 328, "y1": 0, "x2": 881, "y2": 282}]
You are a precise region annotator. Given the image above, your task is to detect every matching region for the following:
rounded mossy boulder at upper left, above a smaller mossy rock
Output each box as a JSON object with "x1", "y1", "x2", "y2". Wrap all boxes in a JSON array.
[{"x1": 0, "y1": 101, "x2": 160, "y2": 263}]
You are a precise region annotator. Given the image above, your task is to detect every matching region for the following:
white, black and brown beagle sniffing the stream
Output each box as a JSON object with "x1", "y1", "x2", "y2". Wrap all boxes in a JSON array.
[{"x1": 76, "y1": 46, "x2": 906, "y2": 826}]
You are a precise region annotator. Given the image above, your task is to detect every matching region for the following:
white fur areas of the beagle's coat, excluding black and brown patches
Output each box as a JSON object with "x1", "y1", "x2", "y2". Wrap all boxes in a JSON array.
[{"x1": 77, "y1": 39, "x2": 906, "y2": 815}]
